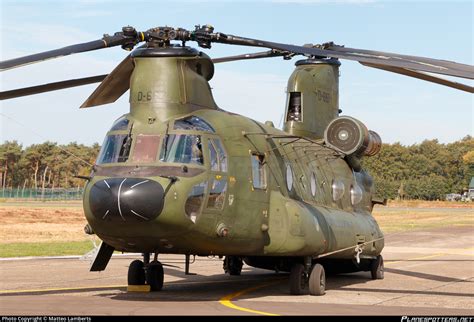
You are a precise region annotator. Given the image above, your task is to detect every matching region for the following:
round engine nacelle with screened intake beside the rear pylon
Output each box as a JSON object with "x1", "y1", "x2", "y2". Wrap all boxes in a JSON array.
[{"x1": 324, "y1": 116, "x2": 382, "y2": 157}]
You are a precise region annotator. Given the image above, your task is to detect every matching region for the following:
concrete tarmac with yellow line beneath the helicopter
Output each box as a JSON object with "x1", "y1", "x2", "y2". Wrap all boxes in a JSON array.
[{"x1": 0, "y1": 227, "x2": 474, "y2": 316}]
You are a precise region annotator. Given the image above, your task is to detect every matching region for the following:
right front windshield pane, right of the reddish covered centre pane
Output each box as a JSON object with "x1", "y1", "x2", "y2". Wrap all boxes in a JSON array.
[{"x1": 160, "y1": 134, "x2": 204, "y2": 165}]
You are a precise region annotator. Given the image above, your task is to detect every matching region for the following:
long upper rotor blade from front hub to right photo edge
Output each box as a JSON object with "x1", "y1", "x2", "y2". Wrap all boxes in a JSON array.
[{"x1": 214, "y1": 34, "x2": 474, "y2": 79}]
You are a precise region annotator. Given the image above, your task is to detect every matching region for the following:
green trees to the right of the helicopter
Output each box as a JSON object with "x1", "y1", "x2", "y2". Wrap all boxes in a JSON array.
[{"x1": 362, "y1": 136, "x2": 474, "y2": 200}]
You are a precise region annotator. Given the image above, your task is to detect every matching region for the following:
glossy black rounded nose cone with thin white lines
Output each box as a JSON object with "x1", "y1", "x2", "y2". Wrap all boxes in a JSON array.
[{"x1": 89, "y1": 178, "x2": 164, "y2": 222}]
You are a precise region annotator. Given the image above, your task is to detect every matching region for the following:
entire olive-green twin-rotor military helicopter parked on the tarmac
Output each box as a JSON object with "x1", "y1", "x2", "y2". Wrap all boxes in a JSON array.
[{"x1": 0, "y1": 25, "x2": 474, "y2": 295}]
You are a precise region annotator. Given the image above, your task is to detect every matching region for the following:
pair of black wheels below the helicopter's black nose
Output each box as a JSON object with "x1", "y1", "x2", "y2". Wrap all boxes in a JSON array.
[{"x1": 128, "y1": 253, "x2": 164, "y2": 291}]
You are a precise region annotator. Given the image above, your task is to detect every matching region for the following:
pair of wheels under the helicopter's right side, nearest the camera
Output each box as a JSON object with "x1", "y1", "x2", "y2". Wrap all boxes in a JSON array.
[{"x1": 290, "y1": 258, "x2": 326, "y2": 296}]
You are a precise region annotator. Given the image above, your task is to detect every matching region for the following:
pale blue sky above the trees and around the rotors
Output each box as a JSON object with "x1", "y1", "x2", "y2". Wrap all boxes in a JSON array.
[{"x1": 0, "y1": 0, "x2": 474, "y2": 145}]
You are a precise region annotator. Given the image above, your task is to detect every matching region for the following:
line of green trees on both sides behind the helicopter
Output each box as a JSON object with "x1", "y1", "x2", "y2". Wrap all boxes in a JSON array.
[{"x1": 0, "y1": 136, "x2": 474, "y2": 200}]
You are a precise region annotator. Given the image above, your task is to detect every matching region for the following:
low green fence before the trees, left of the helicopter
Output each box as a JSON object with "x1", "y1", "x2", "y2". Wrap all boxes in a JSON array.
[{"x1": 0, "y1": 187, "x2": 84, "y2": 200}]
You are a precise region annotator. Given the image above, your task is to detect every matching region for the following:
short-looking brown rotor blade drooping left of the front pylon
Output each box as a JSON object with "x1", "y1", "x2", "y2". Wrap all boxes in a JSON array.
[{"x1": 81, "y1": 55, "x2": 135, "y2": 108}]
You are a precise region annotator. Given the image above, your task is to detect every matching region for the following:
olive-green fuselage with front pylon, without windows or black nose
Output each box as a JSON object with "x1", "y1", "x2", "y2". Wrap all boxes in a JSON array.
[{"x1": 84, "y1": 49, "x2": 383, "y2": 259}]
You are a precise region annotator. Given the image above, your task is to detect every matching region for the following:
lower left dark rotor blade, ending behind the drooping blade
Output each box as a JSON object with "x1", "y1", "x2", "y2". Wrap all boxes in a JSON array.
[{"x1": 0, "y1": 75, "x2": 107, "y2": 101}]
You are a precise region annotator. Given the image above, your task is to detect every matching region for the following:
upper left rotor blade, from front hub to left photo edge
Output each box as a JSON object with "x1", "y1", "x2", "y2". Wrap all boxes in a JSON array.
[{"x1": 0, "y1": 27, "x2": 145, "y2": 71}]
